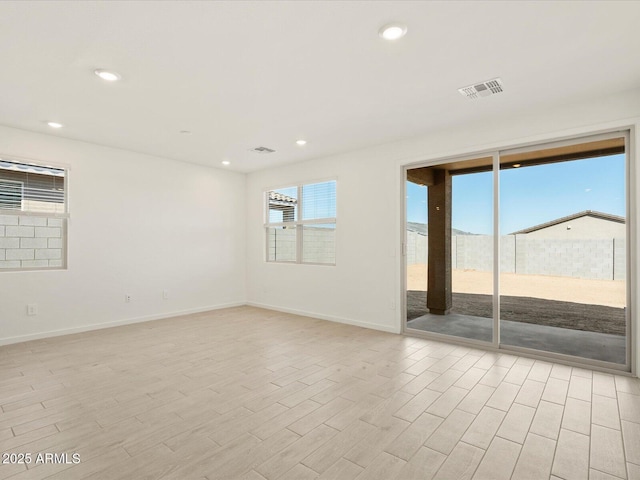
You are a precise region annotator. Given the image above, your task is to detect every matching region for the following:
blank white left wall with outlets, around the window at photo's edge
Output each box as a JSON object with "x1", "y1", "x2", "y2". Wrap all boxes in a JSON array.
[{"x1": 0, "y1": 127, "x2": 246, "y2": 344}]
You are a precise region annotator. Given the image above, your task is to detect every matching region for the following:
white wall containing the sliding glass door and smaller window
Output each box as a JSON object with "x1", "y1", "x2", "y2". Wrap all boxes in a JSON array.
[{"x1": 247, "y1": 90, "x2": 640, "y2": 376}]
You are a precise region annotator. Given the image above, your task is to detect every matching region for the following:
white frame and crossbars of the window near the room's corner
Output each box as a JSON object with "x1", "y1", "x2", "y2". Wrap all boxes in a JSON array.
[{"x1": 263, "y1": 177, "x2": 338, "y2": 267}]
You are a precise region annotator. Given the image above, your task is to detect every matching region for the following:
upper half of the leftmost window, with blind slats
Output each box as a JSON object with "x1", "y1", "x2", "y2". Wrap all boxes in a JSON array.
[{"x1": 0, "y1": 159, "x2": 66, "y2": 214}]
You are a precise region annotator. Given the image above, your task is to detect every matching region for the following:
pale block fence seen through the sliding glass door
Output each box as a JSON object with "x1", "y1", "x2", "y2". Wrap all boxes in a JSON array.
[{"x1": 407, "y1": 232, "x2": 626, "y2": 280}]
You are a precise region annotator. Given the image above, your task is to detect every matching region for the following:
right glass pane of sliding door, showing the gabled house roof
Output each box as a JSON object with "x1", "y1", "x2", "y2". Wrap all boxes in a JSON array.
[{"x1": 500, "y1": 150, "x2": 627, "y2": 364}]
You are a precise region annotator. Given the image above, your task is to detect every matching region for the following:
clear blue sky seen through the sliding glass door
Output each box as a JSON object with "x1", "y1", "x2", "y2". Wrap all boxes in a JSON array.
[{"x1": 407, "y1": 155, "x2": 626, "y2": 234}]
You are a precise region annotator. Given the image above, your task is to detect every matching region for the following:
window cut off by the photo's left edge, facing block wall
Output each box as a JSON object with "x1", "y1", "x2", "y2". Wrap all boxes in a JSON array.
[{"x1": 0, "y1": 158, "x2": 69, "y2": 272}]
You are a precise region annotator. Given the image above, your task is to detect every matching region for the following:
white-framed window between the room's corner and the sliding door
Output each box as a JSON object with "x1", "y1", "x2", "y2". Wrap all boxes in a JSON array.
[{"x1": 265, "y1": 180, "x2": 336, "y2": 265}]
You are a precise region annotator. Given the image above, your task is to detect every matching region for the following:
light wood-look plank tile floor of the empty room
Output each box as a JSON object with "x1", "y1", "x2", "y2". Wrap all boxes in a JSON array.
[{"x1": 0, "y1": 307, "x2": 640, "y2": 480}]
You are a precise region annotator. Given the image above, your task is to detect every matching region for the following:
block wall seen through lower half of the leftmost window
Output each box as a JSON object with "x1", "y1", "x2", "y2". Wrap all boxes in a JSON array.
[{"x1": 0, "y1": 215, "x2": 66, "y2": 269}]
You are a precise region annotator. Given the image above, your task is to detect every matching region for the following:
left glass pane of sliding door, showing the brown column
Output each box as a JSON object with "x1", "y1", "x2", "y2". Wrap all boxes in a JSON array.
[{"x1": 406, "y1": 158, "x2": 493, "y2": 342}]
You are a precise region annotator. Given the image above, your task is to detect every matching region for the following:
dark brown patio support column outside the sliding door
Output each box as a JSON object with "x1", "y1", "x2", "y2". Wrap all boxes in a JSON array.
[{"x1": 427, "y1": 169, "x2": 453, "y2": 315}]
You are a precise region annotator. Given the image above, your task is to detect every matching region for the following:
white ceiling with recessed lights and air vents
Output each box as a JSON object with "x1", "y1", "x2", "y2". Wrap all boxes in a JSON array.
[{"x1": 0, "y1": 1, "x2": 640, "y2": 172}]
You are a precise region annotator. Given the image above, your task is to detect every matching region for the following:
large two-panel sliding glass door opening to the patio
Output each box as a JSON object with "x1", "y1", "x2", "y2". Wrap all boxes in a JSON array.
[{"x1": 405, "y1": 133, "x2": 630, "y2": 369}]
